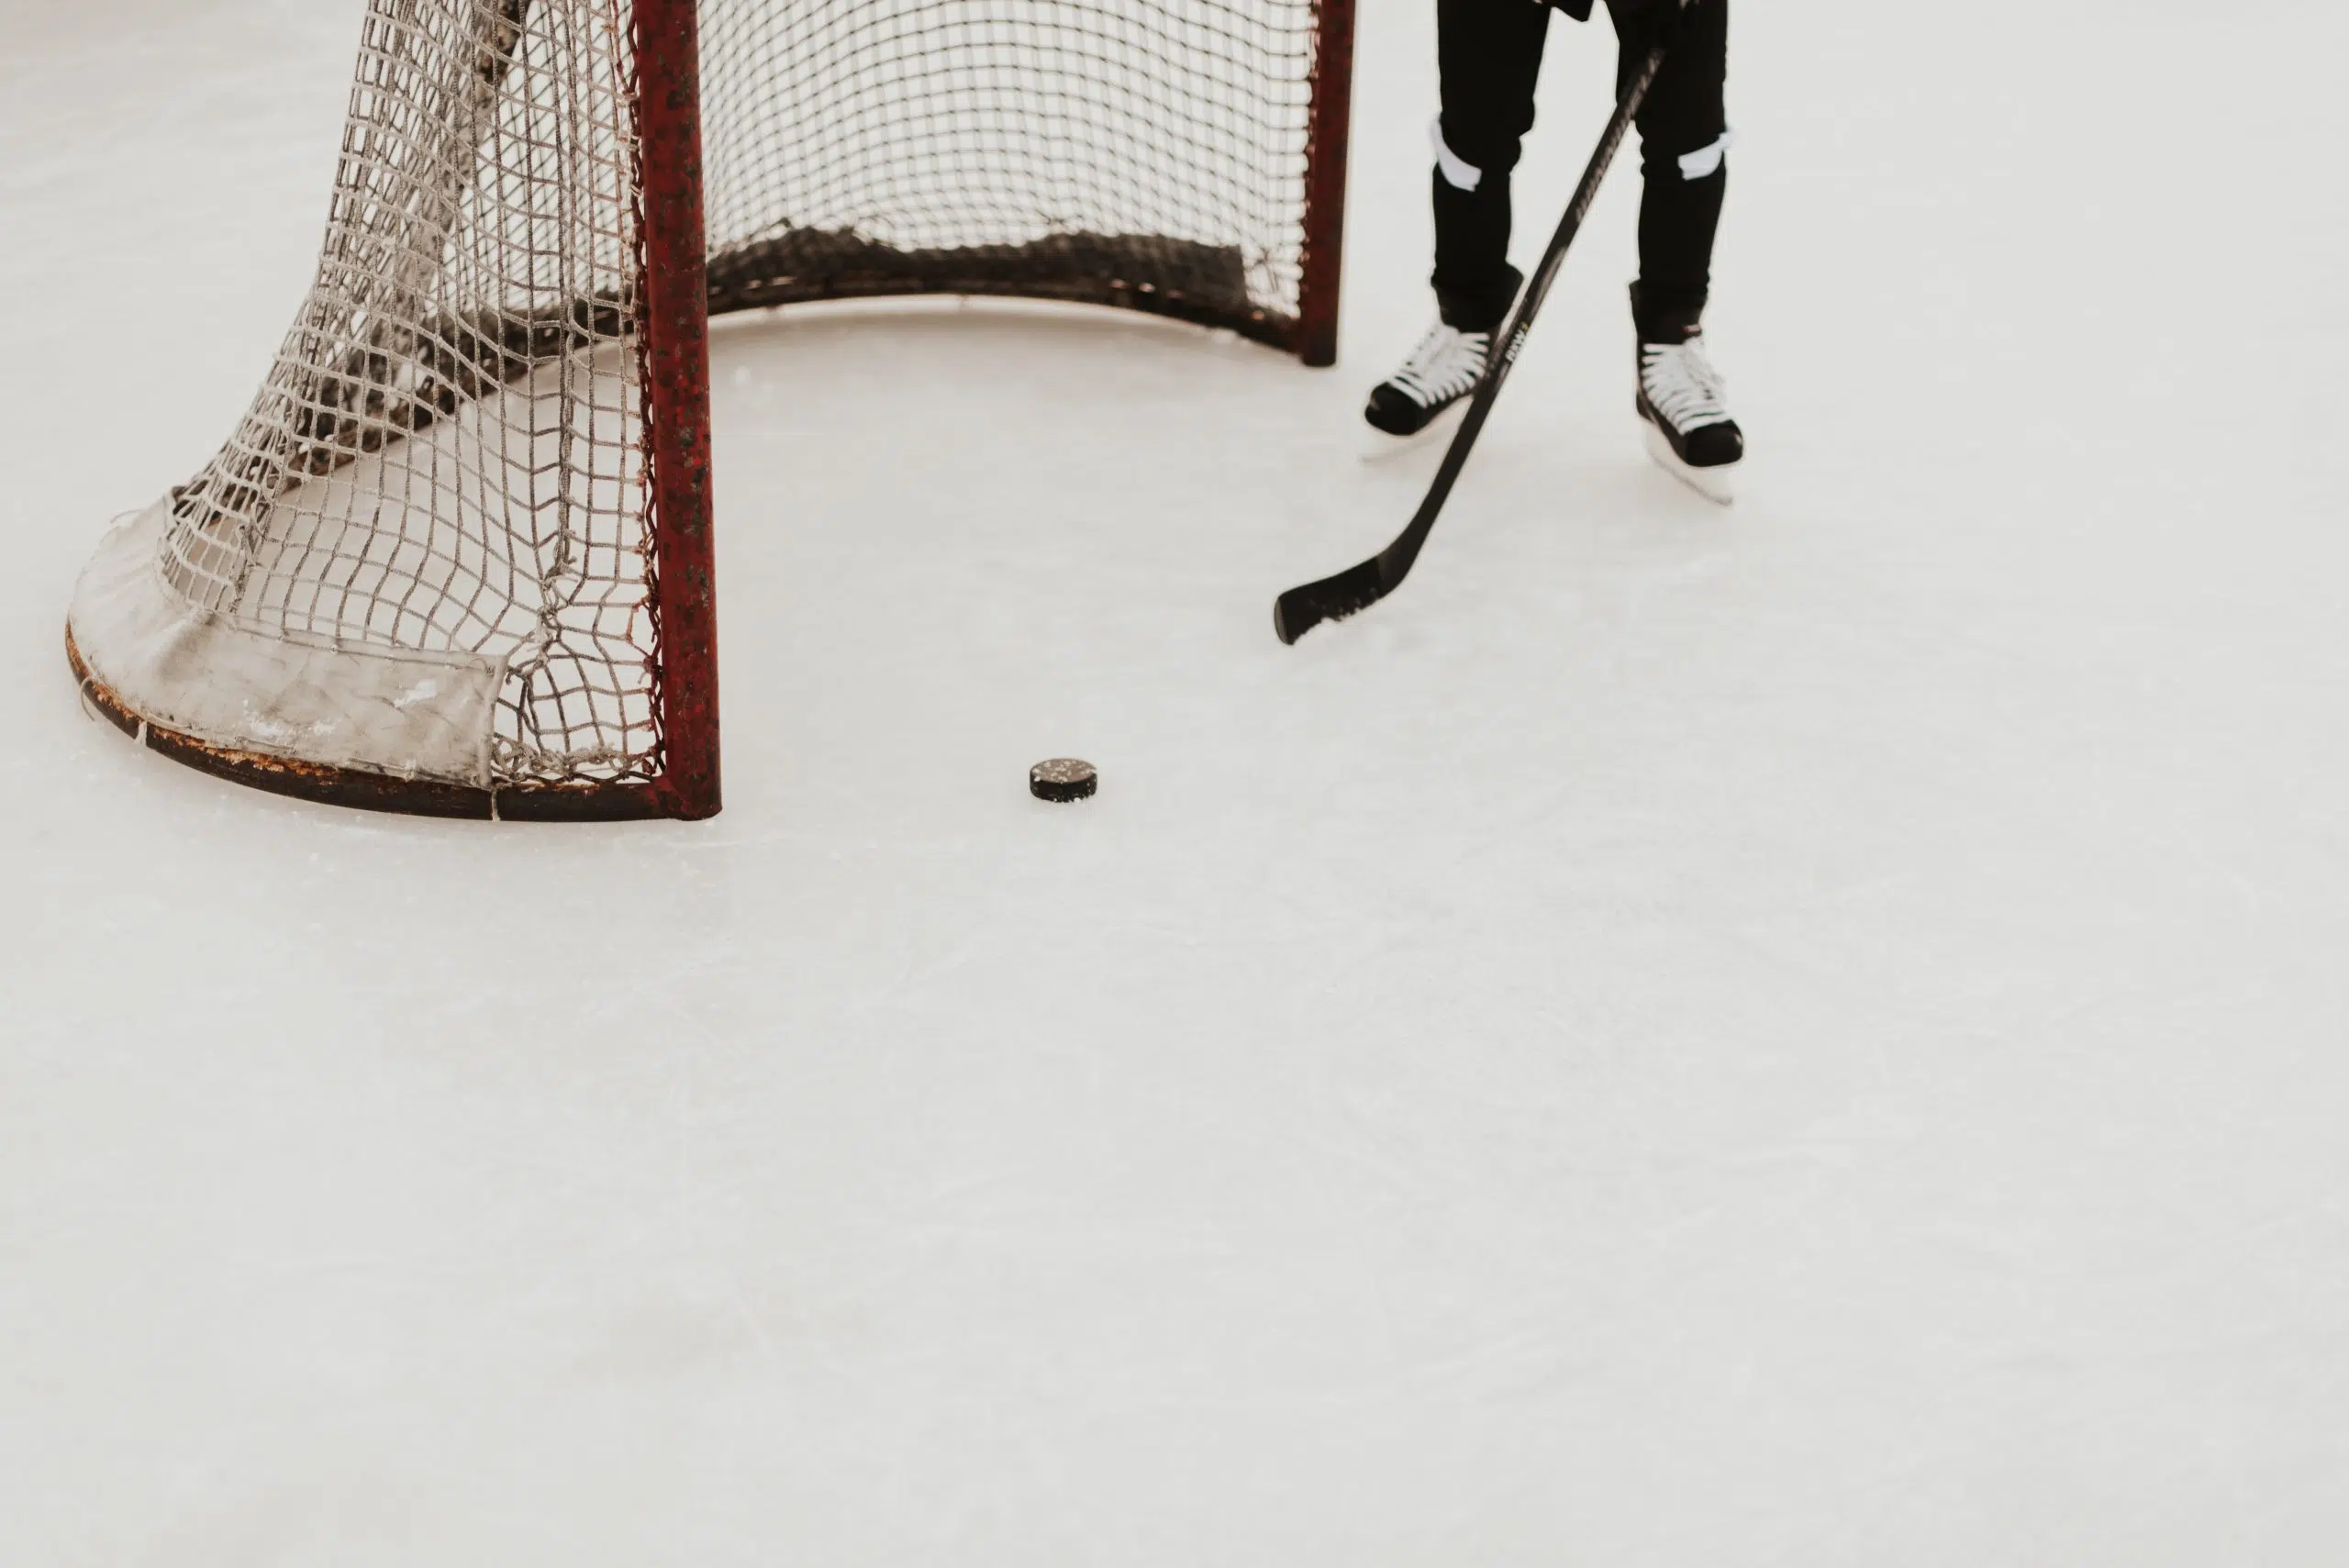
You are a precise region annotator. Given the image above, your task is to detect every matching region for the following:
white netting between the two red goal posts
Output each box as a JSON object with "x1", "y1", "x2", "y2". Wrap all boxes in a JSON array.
[{"x1": 702, "y1": 0, "x2": 1316, "y2": 317}]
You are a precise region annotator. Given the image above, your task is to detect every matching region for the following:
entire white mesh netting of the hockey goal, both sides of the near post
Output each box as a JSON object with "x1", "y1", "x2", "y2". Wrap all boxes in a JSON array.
[{"x1": 141, "y1": 0, "x2": 1316, "y2": 786}]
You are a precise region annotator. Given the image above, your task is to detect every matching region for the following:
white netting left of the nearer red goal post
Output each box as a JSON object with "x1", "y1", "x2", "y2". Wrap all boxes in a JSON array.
[{"x1": 164, "y1": 0, "x2": 658, "y2": 782}]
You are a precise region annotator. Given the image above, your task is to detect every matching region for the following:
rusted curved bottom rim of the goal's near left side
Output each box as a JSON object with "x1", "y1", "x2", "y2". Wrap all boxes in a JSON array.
[{"x1": 66, "y1": 627, "x2": 686, "y2": 821}]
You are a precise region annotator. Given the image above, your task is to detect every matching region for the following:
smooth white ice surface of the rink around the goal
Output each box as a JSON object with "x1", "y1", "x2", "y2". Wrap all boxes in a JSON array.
[{"x1": 0, "y1": 0, "x2": 2349, "y2": 1568}]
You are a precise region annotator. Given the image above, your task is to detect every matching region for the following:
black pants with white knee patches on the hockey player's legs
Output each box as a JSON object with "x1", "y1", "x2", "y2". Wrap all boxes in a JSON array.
[{"x1": 1435, "y1": 0, "x2": 1729, "y2": 338}]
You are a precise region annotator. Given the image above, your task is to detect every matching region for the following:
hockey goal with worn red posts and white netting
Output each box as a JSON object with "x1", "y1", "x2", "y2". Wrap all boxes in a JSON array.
[{"x1": 68, "y1": 0, "x2": 1351, "y2": 817}]
